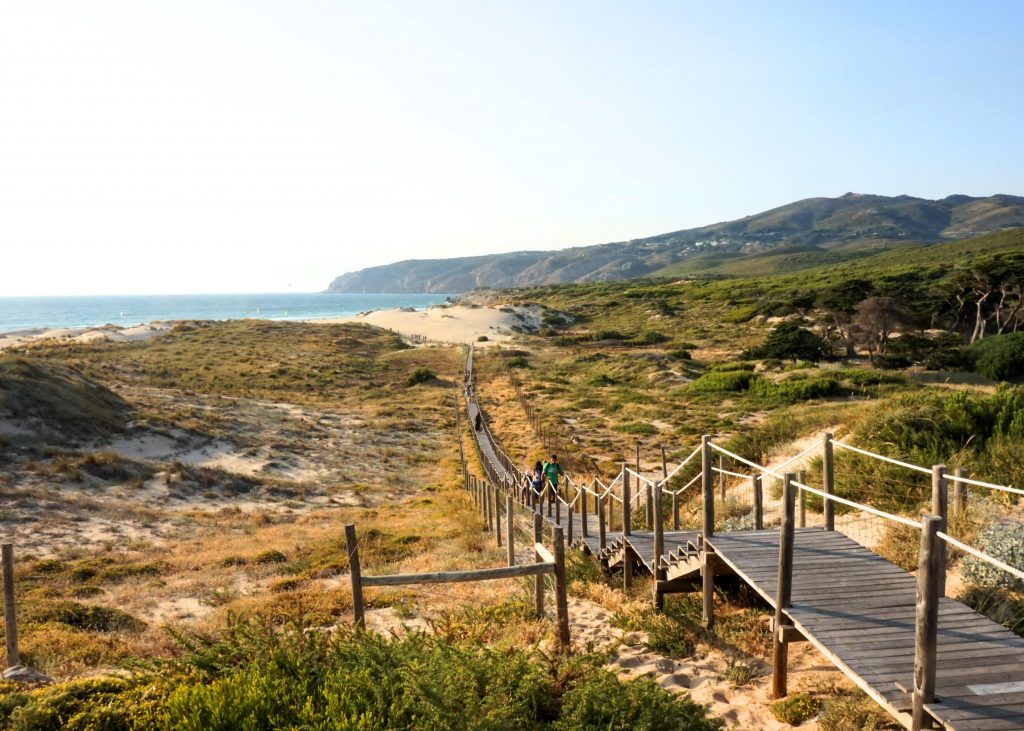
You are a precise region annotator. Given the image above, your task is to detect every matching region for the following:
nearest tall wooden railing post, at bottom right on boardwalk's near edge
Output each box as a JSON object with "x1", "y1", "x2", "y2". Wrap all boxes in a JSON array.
[{"x1": 910, "y1": 515, "x2": 945, "y2": 731}]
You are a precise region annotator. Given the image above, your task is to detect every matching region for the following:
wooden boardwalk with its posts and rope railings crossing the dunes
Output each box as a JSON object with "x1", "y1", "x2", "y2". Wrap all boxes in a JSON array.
[{"x1": 465, "y1": 348, "x2": 1024, "y2": 731}]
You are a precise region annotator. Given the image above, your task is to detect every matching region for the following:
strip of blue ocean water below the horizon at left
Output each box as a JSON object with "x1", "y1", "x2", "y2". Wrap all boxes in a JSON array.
[{"x1": 0, "y1": 294, "x2": 449, "y2": 333}]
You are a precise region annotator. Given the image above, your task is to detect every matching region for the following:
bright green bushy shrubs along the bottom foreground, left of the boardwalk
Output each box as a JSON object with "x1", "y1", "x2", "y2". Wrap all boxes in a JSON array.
[{"x1": 0, "y1": 621, "x2": 721, "y2": 731}]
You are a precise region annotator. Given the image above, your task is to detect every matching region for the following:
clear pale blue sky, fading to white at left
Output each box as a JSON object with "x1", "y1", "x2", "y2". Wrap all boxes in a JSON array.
[{"x1": 0, "y1": 0, "x2": 1024, "y2": 296}]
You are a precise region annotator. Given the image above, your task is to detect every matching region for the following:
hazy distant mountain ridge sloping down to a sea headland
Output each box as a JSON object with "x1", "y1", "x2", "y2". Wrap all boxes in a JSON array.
[{"x1": 328, "y1": 192, "x2": 1024, "y2": 293}]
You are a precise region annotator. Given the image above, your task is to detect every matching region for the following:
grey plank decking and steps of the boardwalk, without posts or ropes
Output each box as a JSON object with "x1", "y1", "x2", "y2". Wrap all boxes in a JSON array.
[{"x1": 468, "y1": 362, "x2": 1024, "y2": 731}]
